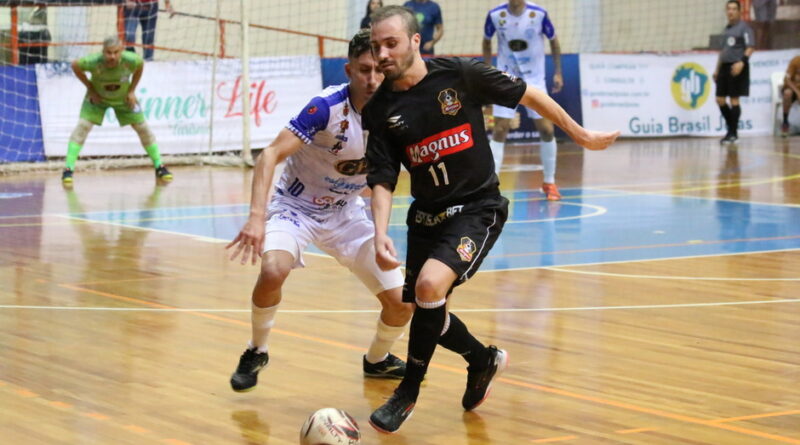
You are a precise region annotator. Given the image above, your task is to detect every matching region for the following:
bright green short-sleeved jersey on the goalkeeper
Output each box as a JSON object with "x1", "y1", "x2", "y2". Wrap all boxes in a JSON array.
[{"x1": 78, "y1": 51, "x2": 144, "y2": 105}]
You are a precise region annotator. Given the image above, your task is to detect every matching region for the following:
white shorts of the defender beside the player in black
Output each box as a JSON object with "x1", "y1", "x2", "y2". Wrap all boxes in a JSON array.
[{"x1": 264, "y1": 198, "x2": 404, "y2": 294}]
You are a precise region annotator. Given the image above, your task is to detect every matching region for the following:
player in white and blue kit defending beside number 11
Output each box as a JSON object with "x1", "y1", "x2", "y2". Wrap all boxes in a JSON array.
[{"x1": 228, "y1": 30, "x2": 413, "y2": 392}]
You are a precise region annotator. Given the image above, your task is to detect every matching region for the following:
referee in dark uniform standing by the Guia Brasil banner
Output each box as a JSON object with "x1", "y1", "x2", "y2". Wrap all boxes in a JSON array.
[{"x1": 714, "y1": 0, "x2": 755, "y2": 144}]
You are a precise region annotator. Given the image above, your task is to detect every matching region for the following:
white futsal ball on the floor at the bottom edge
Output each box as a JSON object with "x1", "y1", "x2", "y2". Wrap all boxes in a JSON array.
[{"x1": 300, "y1": 408, "x2": 361, "y2": 445}]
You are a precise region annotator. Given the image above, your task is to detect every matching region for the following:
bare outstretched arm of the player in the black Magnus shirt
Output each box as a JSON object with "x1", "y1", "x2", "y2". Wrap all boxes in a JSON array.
[{"x1": 520, "y1": 85, "x2": 619, "y2": 150}]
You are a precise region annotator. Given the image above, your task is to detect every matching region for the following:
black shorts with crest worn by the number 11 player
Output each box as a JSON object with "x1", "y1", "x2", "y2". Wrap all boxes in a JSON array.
[{"x1": 403, "y1": 194, "x2": 508, "y2": 303}]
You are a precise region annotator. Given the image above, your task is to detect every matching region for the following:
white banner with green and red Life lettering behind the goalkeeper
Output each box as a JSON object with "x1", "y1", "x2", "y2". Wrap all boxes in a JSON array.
[{"x1": 36, "y1": 56, "x2": 322, "y2": 156}]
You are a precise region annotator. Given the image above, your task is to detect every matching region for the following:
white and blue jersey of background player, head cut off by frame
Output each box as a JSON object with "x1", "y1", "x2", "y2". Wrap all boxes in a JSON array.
[{"x1": 483, "y1": 2, "x2": 556, "y2": 85}]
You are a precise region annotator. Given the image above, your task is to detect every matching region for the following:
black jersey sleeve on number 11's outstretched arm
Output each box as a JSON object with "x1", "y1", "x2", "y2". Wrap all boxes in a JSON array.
[{"x1": 461, "y1": 59, "x2": 527, "y2": 108}]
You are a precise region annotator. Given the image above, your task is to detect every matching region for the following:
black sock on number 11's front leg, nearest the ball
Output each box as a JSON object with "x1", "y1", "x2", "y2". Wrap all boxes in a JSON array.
[{"x1": 398, "y1": 300, "x2": 447, "y2": 400}]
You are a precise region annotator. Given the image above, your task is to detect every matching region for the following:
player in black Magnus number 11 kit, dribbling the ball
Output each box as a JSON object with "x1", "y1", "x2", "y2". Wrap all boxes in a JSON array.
[{"x1": 362, "y1": 6, "x2": 619, "y2": 433}]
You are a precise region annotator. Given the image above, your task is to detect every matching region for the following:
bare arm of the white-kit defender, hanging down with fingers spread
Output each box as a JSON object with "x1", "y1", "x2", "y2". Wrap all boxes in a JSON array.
[{"x1": 225, "y1": 128, "x2": 303, "y2": 264}]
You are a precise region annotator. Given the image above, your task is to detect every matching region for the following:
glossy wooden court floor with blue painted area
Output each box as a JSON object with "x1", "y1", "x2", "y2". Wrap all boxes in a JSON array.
[{"x1": 0, "y1": 137, "x2": 800, "y2": 445}]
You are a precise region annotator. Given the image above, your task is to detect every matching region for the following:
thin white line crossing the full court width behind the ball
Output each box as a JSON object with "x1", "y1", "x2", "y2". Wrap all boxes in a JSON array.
[{"x1": 0, "y1": 298, "x2": 800, "y2": 314}]
